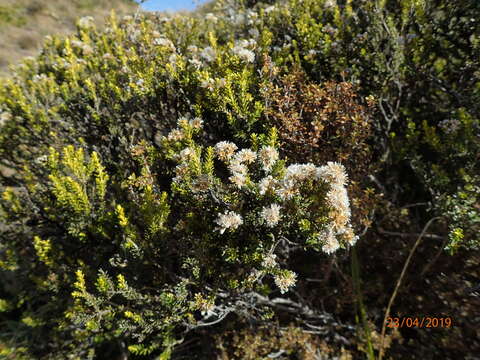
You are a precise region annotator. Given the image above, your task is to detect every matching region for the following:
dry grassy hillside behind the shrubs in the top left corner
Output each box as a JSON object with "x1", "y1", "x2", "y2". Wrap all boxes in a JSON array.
[{"x1": 0, "y1": 0, "x2": 138, "y2": 75}]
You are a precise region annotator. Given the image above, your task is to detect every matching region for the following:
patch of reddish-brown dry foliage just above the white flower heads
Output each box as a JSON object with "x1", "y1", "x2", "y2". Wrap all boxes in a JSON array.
[{"x1": 263, "y1": 58, "x2": 379, "y2": 231}]
